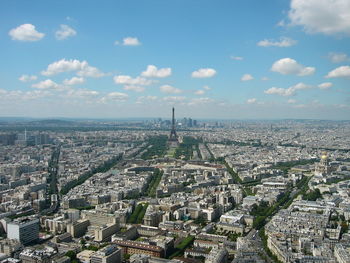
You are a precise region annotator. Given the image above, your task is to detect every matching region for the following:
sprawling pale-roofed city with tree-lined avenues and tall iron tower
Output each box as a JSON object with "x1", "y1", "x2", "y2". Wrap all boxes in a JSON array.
[{"x1": 0, "y1": 111, "x2": 350, "y2": 263}]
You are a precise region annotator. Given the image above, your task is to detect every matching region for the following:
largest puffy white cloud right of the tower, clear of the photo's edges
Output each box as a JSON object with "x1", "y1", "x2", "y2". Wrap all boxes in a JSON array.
[{"x1": 271, "y1": 58, "x2": 316, "y2": 76}]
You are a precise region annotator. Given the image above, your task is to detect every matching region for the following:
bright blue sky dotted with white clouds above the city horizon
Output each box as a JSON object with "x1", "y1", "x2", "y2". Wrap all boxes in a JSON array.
[{"x1": 0, "y1": 0, "x2": 350, "y2": 119}]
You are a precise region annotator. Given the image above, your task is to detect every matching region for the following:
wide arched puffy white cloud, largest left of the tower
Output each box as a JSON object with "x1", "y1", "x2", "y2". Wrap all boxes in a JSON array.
[{"x1": 41, "y1": 58, "x2": 106, "y2": 78}]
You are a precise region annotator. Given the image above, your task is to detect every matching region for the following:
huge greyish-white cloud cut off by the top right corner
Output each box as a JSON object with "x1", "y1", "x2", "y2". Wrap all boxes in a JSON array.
[{"x1": 288, "y1": 0, "x2": 350, "y2": 35}]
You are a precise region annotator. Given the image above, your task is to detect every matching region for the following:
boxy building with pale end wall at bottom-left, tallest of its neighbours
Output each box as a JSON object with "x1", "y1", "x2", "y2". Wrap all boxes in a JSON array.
[{"x1": 7, "y1": 217, "x2": 39, "y2": 245}]
